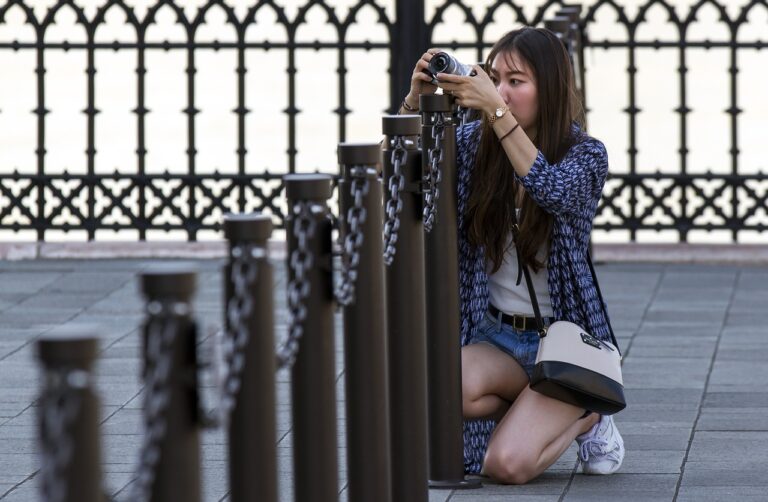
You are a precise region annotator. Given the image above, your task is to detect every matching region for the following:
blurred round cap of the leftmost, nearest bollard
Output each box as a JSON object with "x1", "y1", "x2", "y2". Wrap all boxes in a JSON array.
[{"x1": 37, "y1": 326, "x2": 99, "y2": 369}]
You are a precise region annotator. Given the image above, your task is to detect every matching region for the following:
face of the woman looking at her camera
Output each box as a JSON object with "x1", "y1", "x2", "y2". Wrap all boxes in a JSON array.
[{"x1": 491, "y1": 52, "x2": 539, "y2": 137}]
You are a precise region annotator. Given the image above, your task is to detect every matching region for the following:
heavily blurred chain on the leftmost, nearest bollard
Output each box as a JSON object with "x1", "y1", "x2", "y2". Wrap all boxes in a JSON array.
[{"x1": 40, "y1": 368, "x2": 90, "y2": 502}]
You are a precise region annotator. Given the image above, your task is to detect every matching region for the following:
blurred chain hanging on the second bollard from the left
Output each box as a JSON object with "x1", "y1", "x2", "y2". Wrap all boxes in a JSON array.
[{"x1": 131, "y1": 301, "x2": 189, "y2": 502}]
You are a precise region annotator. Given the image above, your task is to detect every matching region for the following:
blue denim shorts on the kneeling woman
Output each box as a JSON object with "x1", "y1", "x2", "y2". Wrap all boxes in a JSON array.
[{"x1": 469, "y1": 312, "x2": 539, "y2": 378}]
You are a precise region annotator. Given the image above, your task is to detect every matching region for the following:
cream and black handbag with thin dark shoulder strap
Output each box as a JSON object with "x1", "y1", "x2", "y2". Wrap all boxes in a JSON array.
[{"x1": 512, "y1": 211, "x2": 627, "y2": 415}]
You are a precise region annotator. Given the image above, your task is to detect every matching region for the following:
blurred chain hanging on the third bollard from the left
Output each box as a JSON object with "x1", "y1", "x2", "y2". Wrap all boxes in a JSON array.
[{"x1": 219, "y1": 244, "x2": 266, "y2": 424}]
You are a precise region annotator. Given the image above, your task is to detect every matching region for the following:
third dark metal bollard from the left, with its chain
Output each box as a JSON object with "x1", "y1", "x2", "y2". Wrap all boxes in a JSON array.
[{"x1": 222, "y1": 214, "x2": 278, "y2": 502}]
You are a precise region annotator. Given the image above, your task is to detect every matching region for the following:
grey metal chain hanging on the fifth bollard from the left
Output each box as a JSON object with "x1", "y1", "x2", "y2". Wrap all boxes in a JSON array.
[{"x1": 335, "y1": 166, "x2": 370, "y2": 306}]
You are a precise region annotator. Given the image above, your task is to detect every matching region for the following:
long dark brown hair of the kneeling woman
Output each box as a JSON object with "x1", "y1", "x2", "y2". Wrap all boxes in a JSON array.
[{"x1": 467, "y1": 27, "x2": 583, "y2": 272}]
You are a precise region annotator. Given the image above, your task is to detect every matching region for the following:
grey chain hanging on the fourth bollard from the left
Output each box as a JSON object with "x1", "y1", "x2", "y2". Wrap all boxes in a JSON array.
[{"x1": 277, "y1": 201, "x2": 316, "y2": 368}]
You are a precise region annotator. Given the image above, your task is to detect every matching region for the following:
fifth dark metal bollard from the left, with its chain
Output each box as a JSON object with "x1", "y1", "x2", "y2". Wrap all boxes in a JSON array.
[{"x1": 339, "y1": 143, "x2": 392, "y2": 502}]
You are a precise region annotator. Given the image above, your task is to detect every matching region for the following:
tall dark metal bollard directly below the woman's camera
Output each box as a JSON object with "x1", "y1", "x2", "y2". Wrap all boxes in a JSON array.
[{"x1": 419, "y1": 95, "x2": 481, "y2": 488}]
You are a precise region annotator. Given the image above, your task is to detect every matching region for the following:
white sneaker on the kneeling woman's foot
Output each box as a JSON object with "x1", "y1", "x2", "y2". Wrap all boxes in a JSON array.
[{"x1": 576, "y1": 415, "x2": 624, "y2": 474}]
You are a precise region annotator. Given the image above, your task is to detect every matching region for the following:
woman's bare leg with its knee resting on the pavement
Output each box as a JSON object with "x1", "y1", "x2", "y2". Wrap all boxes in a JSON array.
[{"x1": 483, "y1": 387, "x2": 600, "y2": 484}]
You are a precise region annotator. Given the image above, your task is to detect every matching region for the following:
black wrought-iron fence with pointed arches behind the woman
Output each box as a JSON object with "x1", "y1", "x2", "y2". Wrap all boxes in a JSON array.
[{"x1": 0, "y1": 0, "x2": 768, "y2": 242}]
